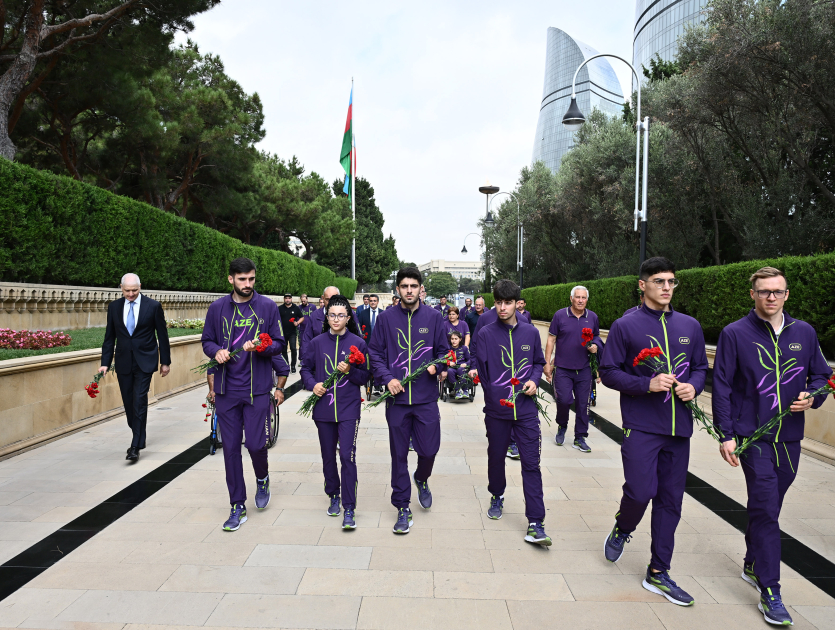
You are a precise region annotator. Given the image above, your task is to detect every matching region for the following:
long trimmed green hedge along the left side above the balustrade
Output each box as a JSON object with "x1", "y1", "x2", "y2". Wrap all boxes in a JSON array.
[{"x1": 0, "y1": 159, "x2": 356, "y2": 298}]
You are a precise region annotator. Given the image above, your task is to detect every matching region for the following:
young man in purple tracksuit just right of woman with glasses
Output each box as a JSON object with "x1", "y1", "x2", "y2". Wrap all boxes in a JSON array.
[{"x1": 369, "y1": 267, "x2": 449, "y2": 534}]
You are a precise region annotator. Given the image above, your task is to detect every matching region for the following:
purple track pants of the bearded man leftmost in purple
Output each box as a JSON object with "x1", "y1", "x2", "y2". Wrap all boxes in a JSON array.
[{"x1": 215, "y1": 391, "x2": 270, "y2": 505}]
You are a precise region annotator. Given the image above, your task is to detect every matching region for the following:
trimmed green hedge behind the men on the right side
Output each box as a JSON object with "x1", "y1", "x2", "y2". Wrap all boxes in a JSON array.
[{"x1": 522, "y1": 254, "x2": 835, "y2": 359}]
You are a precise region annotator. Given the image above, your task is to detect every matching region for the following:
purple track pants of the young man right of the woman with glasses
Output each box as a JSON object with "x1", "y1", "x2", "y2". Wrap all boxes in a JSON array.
[{"x1": 386, "y1": 401, "x2": 441, "y2": 508}]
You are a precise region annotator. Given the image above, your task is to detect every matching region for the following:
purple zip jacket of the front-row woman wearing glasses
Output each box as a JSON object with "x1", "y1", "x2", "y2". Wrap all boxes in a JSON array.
[{"x1": 301, "y1": 330, "x2": 368, "y2": 422}]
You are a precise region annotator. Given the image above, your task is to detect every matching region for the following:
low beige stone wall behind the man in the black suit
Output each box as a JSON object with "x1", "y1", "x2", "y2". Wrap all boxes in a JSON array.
[{"x1": 0, "y1": 335, "x2": 206, "y2": 456}]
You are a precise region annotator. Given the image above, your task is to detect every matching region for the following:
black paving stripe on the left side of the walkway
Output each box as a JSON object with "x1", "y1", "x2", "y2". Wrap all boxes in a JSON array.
[{"x1": 0, "y1": 381, "x2": 302, "y2": 601}]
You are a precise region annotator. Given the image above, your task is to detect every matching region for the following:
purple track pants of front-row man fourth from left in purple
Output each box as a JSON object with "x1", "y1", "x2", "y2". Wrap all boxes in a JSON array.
[{"x1": 484, "y1": 416, "x2": 545, "y2": 521}]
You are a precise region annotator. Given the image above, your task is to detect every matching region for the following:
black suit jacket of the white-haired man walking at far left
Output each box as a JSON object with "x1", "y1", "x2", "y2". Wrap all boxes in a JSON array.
[{"x1": 101, "y1": 294, "x2": 171, "y2": 374}]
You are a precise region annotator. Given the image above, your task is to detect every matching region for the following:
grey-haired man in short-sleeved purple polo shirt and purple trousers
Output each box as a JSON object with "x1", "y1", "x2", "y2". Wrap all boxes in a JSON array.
[{"x1": 545, "y1": 286, "x2": 603, "y2": 453}]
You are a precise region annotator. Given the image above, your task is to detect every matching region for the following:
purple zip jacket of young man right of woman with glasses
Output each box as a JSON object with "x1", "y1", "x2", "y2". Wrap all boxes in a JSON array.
[{"x1": 368, "y1": 304, "x2": 449, "y2": 405}]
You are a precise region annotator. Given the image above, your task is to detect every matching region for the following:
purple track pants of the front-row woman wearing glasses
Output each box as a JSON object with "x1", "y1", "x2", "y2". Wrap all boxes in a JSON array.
[{"x1": 316, "y1": 420, "x2": 360, "y2": 510}]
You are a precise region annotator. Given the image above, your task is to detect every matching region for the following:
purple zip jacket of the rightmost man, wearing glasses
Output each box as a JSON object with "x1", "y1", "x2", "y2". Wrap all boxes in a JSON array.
[{"x1": 712, "y1": 309, "x2": 832, "y2": 442}]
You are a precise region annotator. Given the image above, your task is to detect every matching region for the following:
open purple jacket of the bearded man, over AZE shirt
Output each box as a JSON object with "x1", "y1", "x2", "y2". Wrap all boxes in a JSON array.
[{"x1": 201, "y1": 291, "x2": 286, "y2": 398}]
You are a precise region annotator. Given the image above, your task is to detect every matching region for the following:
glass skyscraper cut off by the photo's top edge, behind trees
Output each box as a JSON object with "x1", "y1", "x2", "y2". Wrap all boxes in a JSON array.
[{"x1": 632, "y1": 0, "x2": 708, "y2": 82}]
